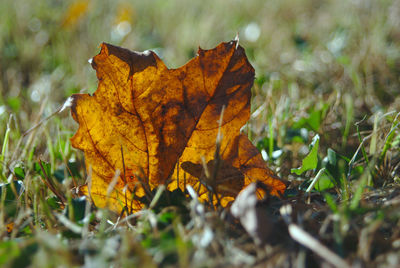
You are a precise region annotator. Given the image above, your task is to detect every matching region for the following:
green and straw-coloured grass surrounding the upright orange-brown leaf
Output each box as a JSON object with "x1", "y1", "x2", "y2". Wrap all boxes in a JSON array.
[{"x1": 0, "y1": 0, "x2": 400, "y2": 267}]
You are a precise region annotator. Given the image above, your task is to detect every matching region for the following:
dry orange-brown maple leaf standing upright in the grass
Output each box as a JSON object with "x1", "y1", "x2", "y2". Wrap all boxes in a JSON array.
[{"x1": 71, "y1": 41, "x2": 286, "y2": 211}]
